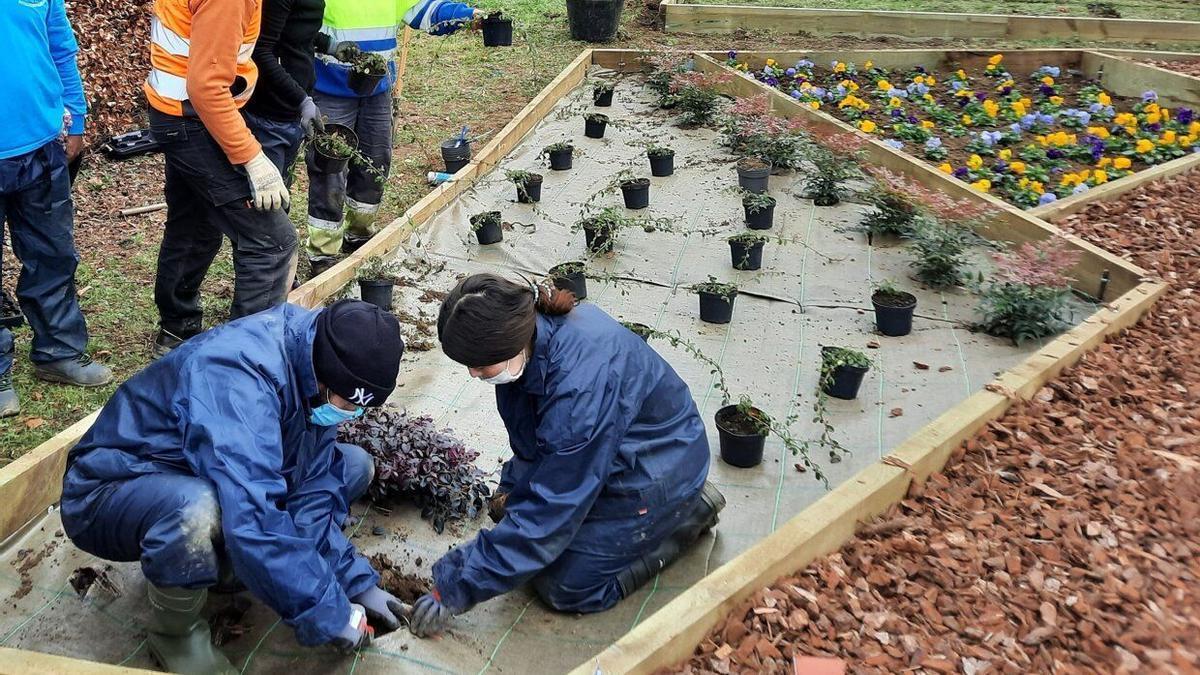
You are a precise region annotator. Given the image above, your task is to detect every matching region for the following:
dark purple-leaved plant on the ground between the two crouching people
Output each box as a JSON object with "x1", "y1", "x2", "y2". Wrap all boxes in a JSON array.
[{"x1": 338, "y1": 406, "x2": 490, "y2": 533}]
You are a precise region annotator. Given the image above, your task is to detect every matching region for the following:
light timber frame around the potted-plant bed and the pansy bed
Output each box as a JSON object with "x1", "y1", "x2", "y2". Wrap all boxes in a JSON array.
[{"x1": 0, "y1": 49, "x2": 1180, "y2": 675}]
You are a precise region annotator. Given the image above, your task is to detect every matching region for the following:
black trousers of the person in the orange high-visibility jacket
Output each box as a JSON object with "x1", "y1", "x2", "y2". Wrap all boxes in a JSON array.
[{"x1": 150, "y1": 109, "x2": 296, "y2": 338}]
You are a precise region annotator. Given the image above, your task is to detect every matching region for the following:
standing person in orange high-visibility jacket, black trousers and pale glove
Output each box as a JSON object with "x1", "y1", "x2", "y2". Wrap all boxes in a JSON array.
[{"x1": 143, "y1": 0, "x2": 296, "y2": 357}]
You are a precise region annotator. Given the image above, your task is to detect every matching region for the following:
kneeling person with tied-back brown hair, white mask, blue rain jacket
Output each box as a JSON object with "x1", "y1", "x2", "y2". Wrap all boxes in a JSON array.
[{"x1": 409, "y1": 274, "x2": 725, "y2": 637}]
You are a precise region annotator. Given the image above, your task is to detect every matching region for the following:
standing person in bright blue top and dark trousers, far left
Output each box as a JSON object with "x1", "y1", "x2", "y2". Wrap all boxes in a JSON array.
[{"x1": 0, "y1": 0, "x2": 113, "y2": 417}]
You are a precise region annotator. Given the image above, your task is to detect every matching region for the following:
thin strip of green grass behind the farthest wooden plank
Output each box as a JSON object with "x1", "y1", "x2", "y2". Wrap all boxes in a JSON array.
[{"x1": 676, "y1": 0, "x2": 1200, "y2": 22}]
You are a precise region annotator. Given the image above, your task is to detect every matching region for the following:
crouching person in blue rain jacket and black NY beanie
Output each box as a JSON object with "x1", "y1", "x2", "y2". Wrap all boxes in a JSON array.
[{"x1": 62, "y1": 300, "x2": 407, "y2": 673}]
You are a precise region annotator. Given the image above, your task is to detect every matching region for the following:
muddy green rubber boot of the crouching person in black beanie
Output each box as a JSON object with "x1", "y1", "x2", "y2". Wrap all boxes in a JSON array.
[{"x1": 146, "y1": 583, "x2": 238, "y2": 675}]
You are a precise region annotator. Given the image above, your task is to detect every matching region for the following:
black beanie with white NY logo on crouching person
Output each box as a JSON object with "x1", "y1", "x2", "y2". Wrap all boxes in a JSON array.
[{"x1": 312, "y1": 300, "x2": 404, "y2": 407}]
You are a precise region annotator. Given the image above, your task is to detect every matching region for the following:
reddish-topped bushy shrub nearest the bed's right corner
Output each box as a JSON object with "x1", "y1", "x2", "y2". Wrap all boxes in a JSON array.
[{"x1": 978, "y1": 238, "x2": 1080, "y2": 345}]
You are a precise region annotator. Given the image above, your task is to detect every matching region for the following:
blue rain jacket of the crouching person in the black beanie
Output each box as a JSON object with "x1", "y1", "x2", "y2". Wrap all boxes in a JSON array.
[{"x1": 62, "y1": 305, "x2": 379, "y2": 645}]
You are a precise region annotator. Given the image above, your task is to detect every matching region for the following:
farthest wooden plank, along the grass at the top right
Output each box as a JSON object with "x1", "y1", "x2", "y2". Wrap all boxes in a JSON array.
[{"x1": 660, "y1": 0, "x2": 1200, "y2": 44}]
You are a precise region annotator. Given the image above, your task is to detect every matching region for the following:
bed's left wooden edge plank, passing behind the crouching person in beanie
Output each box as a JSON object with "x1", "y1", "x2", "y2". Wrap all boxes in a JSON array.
[{"x1": 0, "y1": 49, "x2": 592, "y2": 543}]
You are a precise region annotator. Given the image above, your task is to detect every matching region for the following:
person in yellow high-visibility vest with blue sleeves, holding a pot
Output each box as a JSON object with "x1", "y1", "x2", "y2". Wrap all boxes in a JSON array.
[{"x1": 305, "y1": 0, "x2": 484, "y2": 275}]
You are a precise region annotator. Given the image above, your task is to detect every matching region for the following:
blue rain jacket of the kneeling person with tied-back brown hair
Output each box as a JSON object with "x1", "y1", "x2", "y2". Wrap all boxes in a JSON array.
[{"x1": 433, "y1": 304, "x2": 709, "y2": 613}]
